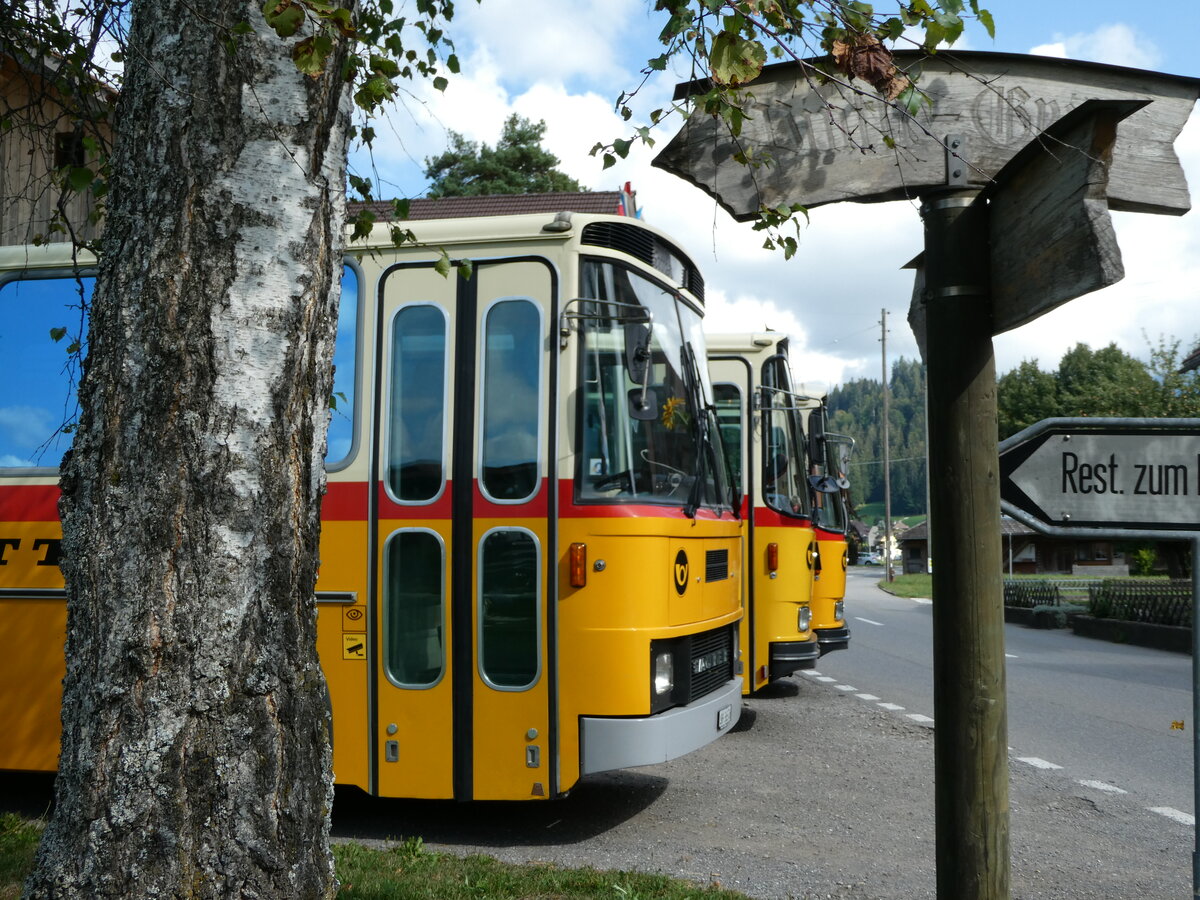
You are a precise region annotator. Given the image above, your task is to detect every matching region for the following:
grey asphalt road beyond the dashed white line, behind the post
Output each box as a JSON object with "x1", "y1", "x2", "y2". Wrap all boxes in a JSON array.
[{"x1": 818, "y1": 569, "x2": 1195, "y2": 821}]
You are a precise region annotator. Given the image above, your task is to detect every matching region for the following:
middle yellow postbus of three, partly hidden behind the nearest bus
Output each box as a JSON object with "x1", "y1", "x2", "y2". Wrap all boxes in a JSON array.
[{"x1": 708, "y1": 331, "x2": 825, "y2": 694}]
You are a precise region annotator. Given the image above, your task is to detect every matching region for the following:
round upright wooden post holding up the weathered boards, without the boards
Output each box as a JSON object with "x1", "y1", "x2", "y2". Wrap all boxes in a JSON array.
[{"x1": 922, "y1": 180, "x2": 1009, "y2": 900}]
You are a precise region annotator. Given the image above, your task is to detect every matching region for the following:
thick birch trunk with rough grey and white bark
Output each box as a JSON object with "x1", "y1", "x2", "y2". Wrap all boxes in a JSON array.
[{"x1": 26, "y1": 0, "x2": 349, "y2": 900}]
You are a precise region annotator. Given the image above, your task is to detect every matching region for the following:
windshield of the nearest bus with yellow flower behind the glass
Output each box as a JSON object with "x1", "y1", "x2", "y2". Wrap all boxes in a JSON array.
[{"x1": 577, "y1": 260, "x2": 731, "y2": 515}]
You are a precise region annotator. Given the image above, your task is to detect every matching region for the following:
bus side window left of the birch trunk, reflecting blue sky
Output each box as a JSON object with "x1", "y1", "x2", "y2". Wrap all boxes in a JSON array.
[{"x1": 0, "y1": 275, "x2": 95, "y2": 469}]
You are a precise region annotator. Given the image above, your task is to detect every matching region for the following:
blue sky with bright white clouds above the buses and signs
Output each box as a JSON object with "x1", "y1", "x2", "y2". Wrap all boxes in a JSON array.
[{"x1": 358, "y1": 0, "x2": 1200, "y2": 386}]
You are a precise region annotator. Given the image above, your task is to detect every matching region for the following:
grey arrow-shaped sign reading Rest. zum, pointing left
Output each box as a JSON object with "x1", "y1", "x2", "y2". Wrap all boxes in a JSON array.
[{"x1": 1000, "y1": 419, "x2": 1200, "y2": 532}]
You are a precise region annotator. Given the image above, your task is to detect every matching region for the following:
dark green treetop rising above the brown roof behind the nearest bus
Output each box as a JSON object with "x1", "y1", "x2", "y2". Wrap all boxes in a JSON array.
[{"x1": 425, "y1": 113, "x2": 583, "y2": 197}]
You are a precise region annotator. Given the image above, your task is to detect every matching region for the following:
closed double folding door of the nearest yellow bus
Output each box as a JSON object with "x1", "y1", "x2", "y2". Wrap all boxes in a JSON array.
[{"x1": 371, "y1": 258, "x2": 558, "y2": 800}]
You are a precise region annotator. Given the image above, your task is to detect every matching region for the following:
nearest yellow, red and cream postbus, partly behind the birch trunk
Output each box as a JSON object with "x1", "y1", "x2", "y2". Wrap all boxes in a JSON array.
[{"x1": 0, "y1": 194, "x2": 743, "y2": 800}]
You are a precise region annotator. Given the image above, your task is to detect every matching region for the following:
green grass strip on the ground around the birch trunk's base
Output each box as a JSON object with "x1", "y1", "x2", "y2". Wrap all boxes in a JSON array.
[{"x1": 0, "y1": 812, "x2": 745, "y2": 900}]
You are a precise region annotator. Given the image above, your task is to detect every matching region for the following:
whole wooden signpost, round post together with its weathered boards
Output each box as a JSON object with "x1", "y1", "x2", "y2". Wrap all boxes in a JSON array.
[{"x1": 655, "y1": 52, "x2": 1200, "y2": 900}]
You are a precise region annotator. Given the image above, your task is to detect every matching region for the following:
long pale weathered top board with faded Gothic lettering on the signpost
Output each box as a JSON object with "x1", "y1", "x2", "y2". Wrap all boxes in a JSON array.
[{"x1": 654, "y1": 52, "x2": 1200, "y2": 220}]
